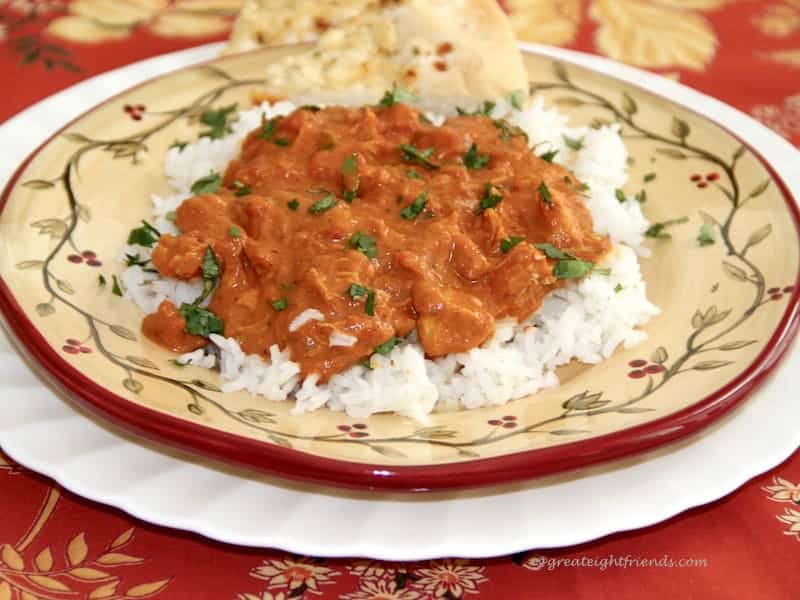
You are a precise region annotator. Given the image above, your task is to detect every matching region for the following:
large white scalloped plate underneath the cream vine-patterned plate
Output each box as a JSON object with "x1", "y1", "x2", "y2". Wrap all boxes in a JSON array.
[{"x1": 0, "y1": 45, "x2": 800, "y2": 560}]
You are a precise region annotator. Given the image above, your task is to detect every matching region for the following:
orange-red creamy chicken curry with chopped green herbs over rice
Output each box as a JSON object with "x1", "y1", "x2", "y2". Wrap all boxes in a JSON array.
[{"x1": 143, "y1": 104, "x2": 610, "y2": 381}]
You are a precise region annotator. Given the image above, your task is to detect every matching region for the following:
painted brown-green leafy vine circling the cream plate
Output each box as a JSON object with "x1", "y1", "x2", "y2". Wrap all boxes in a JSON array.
[{"x1": 10, "y1": 63, "x2": 791, "y2": 459}]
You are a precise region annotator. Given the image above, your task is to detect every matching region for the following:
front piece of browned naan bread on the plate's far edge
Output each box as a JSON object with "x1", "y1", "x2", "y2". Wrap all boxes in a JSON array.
[{"x1": 233, "y1": 0, "x2": 527, "y2": 112}]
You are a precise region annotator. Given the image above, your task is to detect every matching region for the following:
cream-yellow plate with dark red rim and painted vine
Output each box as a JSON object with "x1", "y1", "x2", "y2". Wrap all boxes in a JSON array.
[{"x1": 0, "y1": 47, "x2": 798, "y2": 490}]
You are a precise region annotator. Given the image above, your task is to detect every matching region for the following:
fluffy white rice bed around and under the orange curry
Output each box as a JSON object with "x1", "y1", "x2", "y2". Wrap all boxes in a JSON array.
[{"x1": 121, "y1": 99, "x2": 659, "y2": 421}]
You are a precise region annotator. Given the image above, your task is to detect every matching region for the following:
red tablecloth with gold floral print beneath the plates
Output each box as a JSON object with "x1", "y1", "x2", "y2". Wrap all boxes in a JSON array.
[{"x1": 0, "y1": 0, "x2": 800, "y2": 600}]
